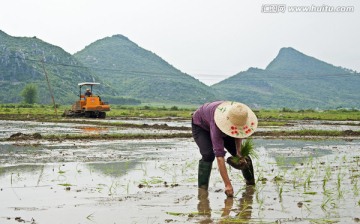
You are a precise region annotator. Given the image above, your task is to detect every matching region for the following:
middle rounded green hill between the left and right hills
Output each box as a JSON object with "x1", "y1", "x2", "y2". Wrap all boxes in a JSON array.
[{"x1": 74, "y1": 35, "x2": 216, "y2": 104}]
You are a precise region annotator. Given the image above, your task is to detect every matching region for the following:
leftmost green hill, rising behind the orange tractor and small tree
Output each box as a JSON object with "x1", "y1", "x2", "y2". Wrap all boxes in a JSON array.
[{"x1": 0, "y1": 31, "x2": 113, "y2": 104}]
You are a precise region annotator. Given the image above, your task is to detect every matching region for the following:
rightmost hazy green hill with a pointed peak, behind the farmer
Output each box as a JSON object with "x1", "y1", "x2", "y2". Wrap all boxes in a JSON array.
[{"x1": 212, "y1": 48, "x2": 360, "y2": 109}]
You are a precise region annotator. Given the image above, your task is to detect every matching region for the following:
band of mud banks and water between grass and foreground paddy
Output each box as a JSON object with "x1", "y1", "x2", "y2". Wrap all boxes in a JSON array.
[{"x1": 0, "y1": 119, "x2": 360, "y2": 141}]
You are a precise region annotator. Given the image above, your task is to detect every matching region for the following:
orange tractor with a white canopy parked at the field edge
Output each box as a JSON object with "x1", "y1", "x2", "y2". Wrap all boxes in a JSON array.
[{"x1": 63, "y1": 82, "x2": 110, "y2": 118}]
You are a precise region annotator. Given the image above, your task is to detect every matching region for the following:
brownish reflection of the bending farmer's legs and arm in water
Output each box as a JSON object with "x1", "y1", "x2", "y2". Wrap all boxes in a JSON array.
[{"x1": 197, "y1": 185, "x2": 255, "y2": 224}]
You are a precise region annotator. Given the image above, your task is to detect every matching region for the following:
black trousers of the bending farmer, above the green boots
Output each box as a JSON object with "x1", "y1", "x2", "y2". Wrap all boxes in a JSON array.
[{"x1": 191, "y1": 123, "x2": 236, "y2": 162}]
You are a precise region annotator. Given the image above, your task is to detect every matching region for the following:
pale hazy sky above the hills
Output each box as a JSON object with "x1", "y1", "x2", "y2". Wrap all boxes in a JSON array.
[{"x1": 0, "y1": 0, "x2": 360, "y2": 84}]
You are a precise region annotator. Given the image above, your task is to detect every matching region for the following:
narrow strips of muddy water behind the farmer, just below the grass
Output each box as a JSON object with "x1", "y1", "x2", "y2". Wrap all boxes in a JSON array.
[{"x1": 0, "y1": 119, "x2": 360, "y2": 139}]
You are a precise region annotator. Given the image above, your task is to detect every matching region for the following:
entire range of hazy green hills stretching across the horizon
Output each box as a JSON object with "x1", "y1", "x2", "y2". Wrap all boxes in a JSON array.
[{"x1": 0, "y1": 31, "x2": 360, "y2": 109}]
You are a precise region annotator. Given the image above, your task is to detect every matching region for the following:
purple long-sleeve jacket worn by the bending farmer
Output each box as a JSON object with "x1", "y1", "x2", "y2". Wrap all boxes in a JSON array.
[{"x1": 193, "y1": 101, "x2": 226, "y2": 157}]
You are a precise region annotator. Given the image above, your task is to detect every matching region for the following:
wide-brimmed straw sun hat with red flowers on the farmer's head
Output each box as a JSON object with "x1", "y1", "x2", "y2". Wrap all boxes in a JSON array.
[{"x1": 214, "y1": 101, "x2": 258, "y2": 138}]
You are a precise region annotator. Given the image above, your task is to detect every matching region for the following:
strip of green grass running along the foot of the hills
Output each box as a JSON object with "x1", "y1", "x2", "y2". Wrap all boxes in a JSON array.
[{"x1": 0, "y1": 104, "x2": 360, "y2": 121}]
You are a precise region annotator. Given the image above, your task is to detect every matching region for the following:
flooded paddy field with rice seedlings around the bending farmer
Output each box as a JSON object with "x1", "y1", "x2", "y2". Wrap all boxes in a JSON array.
[{"x1": 0, "y1": 118, "x2": 360, "y2": 224}]
